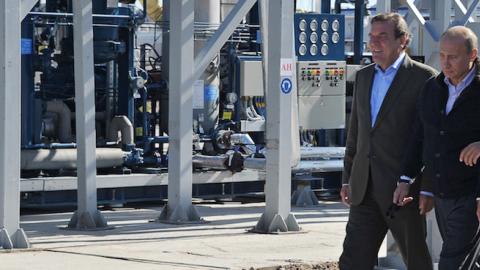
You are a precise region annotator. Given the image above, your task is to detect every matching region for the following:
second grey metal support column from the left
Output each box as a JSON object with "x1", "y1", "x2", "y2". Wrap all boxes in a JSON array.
[{"x1": 68, "y1": 0, "x2": 108, "y2": 230}]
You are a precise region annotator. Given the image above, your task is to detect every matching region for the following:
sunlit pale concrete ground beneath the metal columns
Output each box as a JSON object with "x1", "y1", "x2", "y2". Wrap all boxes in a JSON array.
[{"x1": 0, "y1": 202, "x2": 348, "y2": 270}]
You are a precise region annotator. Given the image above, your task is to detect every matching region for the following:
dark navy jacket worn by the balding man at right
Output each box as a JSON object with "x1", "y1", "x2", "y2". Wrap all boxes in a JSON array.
[{"x1": 403, "y1": 61, "x2": 480, "y2": 198}]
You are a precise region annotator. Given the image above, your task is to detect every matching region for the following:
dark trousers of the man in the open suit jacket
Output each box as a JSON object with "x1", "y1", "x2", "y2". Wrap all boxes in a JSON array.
[{"x1": 339, "y1": 192, "x2": 433, "y2": 270}]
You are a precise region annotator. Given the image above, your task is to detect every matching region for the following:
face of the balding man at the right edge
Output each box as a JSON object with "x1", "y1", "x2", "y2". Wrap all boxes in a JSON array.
[{"x1": 440, "y1": 38, "x2": 477, "y2": 85}]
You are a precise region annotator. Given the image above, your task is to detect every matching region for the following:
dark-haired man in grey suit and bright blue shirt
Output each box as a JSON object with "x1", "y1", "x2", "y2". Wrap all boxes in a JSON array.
[{"x1": 339, "y1": 13, "x2": 436, "y2": 270}]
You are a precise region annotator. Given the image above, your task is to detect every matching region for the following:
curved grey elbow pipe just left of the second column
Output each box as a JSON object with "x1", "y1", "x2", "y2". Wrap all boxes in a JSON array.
[{"x1": 47, "y1": 100, "x2": 72, "y2": 143}]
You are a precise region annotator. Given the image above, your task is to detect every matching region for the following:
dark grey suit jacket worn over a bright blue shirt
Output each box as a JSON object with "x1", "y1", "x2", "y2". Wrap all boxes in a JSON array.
[{"x1": 343, "y1": 56, "x2": 436, "y2": 206}]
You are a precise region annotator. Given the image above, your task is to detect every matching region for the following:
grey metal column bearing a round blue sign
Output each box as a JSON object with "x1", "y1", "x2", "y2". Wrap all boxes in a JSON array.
[{"x1": 252, "y1": 0, "x2": 300, "y2": 233}]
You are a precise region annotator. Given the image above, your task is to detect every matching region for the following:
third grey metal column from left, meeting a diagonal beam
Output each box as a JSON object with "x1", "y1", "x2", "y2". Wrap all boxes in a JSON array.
[{"x1": 158, "y1": 0, "x2": 202, "y2": 224}]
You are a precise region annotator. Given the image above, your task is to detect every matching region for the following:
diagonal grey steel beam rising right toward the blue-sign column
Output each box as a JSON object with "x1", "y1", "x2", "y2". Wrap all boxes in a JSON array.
[{"x1": 193, "y1": 0, "x2": 257, "y2": 79}]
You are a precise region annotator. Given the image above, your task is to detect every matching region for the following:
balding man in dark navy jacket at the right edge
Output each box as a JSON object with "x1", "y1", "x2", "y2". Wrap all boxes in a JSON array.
[{"x1": 393, "y1": 26, "x2": 480, "y2": 270}]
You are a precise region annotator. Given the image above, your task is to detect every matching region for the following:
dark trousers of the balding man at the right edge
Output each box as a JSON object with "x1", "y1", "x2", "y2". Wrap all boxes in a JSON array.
[{"x1": 435, "y1": 195, "x2": 478, "y2": 270}]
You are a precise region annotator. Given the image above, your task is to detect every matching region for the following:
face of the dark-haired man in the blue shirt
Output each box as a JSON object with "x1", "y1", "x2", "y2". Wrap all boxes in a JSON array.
[{"x1": 368, "y1": 22, "x2": 406, "y2": 70}]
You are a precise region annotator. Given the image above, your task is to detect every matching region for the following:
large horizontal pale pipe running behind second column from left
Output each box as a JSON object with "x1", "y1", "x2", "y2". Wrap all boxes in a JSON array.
[{"x1": 21, "y1": 148, "x2": 127, "y2": 170}]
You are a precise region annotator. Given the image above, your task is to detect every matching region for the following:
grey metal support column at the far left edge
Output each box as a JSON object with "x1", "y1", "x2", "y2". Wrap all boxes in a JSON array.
[{"x1": 0, "y1": 0, "x2": 30, "y2": 249}]
